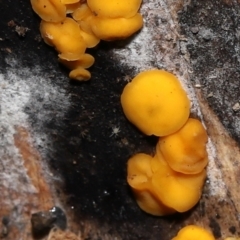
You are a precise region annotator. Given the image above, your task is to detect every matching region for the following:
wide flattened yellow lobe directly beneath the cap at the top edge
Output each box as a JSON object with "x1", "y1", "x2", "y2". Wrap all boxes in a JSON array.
[{"x1": 91, "y1": 13, "x2": 143, "y2": 41}]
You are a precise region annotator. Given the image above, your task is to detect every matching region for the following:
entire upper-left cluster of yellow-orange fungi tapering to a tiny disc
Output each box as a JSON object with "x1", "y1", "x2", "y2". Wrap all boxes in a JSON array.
[{"x1": 31, "y1": 0, "x2": 143, "y2": 81}]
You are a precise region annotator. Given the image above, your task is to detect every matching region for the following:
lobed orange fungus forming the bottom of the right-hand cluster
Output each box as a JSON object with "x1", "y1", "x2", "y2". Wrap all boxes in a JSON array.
[{"x1": 127, "y1": 153, "x2": 206, "y2": 216}]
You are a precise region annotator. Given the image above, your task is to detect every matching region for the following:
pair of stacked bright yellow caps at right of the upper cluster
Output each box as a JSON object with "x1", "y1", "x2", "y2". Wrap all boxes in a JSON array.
[{"x1": 87, "y1": 0, "x2": 143, "y2": 41}]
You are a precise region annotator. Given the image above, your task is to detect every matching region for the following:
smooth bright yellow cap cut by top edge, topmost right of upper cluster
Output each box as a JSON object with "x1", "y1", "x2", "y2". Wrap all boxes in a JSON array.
[{"x1": 87, "y1": 0, "x2": 142, "y2": 18}]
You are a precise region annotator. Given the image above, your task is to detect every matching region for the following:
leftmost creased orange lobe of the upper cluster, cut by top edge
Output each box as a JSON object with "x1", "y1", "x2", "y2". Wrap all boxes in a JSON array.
[{"x1": 31, "y1": 0, "x2": 66, "y2": 22}]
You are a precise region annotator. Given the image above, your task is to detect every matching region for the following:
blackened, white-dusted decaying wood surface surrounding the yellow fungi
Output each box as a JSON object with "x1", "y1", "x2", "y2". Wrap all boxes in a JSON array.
[{"x1": 0, "y1": 0, "x2": 240, "y2": 240}]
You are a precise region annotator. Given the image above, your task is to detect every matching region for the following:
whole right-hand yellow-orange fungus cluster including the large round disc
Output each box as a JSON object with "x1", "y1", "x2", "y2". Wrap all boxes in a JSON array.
[{"x1": 121, "y1": 70, "x2": 208, "y2": 216}]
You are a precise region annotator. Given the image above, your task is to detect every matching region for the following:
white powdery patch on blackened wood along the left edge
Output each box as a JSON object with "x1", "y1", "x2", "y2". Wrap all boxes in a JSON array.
[{"x1": 0, "y1": 59, "x2": 69, "y2": 208}]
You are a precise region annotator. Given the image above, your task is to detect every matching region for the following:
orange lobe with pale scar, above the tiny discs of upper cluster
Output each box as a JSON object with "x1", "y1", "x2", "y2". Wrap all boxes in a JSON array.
[{"x1": 40, "y1": 18, "x2": 86, "y2": 60}]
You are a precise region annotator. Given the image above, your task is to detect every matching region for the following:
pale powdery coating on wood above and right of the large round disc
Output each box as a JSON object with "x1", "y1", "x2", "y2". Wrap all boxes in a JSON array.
[{"x1": 114, "y1": 0, "x2": 226, "y2": 199}]
